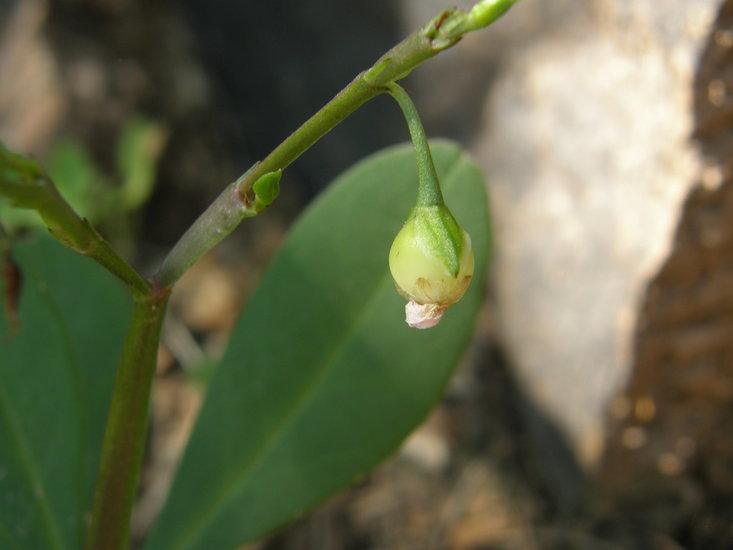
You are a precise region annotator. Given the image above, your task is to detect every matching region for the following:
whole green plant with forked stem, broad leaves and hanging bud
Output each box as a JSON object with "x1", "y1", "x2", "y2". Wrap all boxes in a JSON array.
[{"x1": 0, "y1": 0, "x2": 516, "y2": 550}]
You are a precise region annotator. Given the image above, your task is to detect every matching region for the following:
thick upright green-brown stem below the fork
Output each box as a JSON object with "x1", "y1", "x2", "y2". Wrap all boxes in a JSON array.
[{"x1": 85, "y1": 292, "x2": 169, "y2": 550}]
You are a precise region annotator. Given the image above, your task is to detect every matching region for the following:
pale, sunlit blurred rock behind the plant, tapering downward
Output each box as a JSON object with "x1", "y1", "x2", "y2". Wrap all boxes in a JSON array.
[{"x1": 460, "y1": 0, "x2": 720, "y2": 476}]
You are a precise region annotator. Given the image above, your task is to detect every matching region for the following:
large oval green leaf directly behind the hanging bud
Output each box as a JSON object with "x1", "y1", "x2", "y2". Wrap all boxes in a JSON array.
[{"x1": 145, "y1": 142, "x2": 489, "y2": 550}]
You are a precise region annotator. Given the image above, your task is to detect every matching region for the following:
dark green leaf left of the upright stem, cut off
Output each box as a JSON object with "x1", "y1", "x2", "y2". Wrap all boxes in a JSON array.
[{"x1": 0, "y1": 236, "x2": 130, "y2": 550}]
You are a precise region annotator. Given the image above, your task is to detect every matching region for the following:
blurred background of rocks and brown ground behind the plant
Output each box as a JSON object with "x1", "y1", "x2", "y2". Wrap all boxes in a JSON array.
[{"x1": 0, "y1": 0, "x2": 733, "y2": 550}]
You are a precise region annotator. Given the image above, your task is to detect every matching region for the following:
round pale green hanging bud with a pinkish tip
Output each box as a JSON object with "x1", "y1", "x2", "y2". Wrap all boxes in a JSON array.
[{"x1": 389, "y1": 205, "x2": 473, "y2": 328}]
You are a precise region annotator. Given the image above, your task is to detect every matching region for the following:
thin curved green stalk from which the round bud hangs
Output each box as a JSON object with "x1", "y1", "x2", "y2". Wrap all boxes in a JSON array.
[{"x1": 387, "y1": 82, "x2": 443, "y2": 206}]
